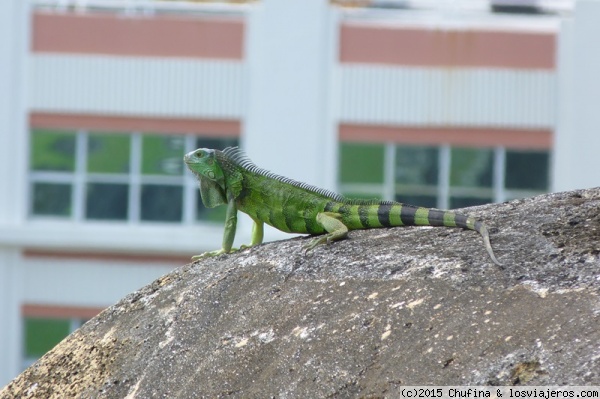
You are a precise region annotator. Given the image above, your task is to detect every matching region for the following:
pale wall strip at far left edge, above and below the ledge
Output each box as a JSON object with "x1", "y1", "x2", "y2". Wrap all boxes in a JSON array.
[{"x1": 0, "y1": 0, "x2": 29, "y2": 386}]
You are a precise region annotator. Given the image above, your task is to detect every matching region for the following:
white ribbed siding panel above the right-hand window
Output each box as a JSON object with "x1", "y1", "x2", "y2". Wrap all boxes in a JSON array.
[{"x1": 339, "y1": 64, "x2": 556, "y2": 128}]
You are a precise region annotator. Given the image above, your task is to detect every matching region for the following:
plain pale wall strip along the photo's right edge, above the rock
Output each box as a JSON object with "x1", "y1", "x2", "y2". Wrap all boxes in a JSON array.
[{"x1": 552, "y1": 0, "x2": 600, "y2": 191}]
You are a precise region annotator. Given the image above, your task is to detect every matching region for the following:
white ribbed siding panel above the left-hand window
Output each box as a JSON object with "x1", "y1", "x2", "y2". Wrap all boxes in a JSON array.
[{"x1": 30, "y1": 53, "x2": 245, "y2": 119}]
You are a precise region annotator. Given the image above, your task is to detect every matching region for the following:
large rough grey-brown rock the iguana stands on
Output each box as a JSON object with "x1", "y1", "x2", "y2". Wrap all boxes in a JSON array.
[{"x1": 0, "y1": 188, "x2": 600, "y2": 398}]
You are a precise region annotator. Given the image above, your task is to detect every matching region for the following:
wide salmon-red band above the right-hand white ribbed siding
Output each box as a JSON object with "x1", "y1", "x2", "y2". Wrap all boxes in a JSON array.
[{"x1": 339, "y1": 23, "x2": 556, "y2": 69}]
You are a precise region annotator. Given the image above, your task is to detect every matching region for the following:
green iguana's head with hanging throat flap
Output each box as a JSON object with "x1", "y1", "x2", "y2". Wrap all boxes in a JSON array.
[{"x1": 183, "y1": 148, "x2": 227, "y2": 208}]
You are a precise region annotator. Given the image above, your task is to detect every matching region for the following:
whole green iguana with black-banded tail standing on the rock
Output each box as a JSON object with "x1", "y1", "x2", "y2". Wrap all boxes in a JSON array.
[{"x1": 184, "y1": 147, "x2": 500, "y2": 265}]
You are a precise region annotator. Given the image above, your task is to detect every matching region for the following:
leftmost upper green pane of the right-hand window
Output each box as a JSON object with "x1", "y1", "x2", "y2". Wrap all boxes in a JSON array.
[{"x1": 339, "y1": 143, "x2": 384, "y2": 183}]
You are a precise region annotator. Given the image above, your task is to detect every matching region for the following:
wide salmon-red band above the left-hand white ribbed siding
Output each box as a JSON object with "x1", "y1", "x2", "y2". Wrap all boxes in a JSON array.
[{"x1": 32, "y1": 11, "x2": 244, "y2": 60}]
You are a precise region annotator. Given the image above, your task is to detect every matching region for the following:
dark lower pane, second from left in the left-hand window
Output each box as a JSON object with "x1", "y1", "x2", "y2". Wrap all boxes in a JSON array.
[{"x1": 85, "y1": 183, "x2": 129, "y2": 220}]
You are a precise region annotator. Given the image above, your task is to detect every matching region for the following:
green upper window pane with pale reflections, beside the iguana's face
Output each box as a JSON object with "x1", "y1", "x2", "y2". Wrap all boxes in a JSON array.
[{"x1": 142, "y1": 135, "x2": 185, "y2": 175}]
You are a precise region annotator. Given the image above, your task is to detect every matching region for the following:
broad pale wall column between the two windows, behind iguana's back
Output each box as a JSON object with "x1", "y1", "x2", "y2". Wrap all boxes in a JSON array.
[{"x1": 243, "y1": 0, "x2": 337, "y2": 188}]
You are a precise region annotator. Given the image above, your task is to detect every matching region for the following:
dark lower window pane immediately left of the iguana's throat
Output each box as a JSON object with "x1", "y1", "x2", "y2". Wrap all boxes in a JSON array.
[{"x1": 141, "y1": 184, "x2": 183, "y2": 222}]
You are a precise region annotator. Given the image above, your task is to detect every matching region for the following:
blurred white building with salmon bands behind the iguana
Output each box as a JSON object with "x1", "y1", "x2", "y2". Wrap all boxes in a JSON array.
[{"x1": 0, "y1": 0, "x2": 600, "y2": 385}]
